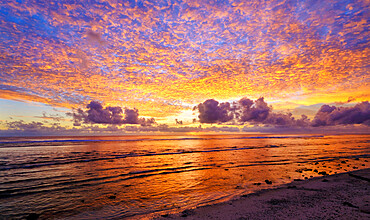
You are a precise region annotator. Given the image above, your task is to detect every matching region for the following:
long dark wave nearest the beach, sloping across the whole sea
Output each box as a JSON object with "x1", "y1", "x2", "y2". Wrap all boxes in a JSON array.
[{"x1": 0, "y1": 154, "x2": 370, "y2": 199}]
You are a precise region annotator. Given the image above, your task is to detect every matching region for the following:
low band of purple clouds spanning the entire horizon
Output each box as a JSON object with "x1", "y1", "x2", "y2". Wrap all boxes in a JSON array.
[{"x1": 0, "y1": 98, "x2": 370, "y2": 136}]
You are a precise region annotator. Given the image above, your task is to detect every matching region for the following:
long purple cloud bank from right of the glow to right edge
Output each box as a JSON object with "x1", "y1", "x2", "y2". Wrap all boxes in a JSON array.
[{"x1": 194, "y1": 98, "x2": 370, "y2": 127}]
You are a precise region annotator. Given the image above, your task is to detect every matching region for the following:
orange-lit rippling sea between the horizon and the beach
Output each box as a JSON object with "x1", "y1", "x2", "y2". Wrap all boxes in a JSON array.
[{"x1": 0, "y1": 135, "x2": 370, "y2": 219}]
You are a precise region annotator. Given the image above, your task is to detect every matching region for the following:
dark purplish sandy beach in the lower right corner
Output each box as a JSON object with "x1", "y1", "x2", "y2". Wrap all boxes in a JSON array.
[{"x1": 149, "y1": 168, "x2": 370, "y2": 220}]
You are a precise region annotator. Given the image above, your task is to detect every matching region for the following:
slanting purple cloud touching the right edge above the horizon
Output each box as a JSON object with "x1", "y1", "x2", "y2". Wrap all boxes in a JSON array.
[{"x1": 312, "y1": 102, "x2": 370, "y2": 127}]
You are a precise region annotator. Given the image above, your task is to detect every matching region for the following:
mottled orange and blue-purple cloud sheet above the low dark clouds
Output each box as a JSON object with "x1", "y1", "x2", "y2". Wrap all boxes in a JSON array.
[{"x1": 0, "y1": 0, "x2": 370, "y2": 123}]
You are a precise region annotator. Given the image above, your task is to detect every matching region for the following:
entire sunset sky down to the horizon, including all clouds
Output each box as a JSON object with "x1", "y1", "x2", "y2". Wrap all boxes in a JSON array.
[{"x1": 0, "y1": 0, "x2": 370, "y2": 136}]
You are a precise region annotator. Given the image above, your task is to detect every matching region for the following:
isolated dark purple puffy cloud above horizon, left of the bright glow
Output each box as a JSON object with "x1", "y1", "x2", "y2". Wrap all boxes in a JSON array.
[{"x1": 67, "y1": 101, "x2": 155, "y2": 126}]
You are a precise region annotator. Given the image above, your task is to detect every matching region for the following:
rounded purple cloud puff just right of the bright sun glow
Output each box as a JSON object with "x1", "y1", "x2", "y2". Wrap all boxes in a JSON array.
[{"x1": 194, "y1": 99, "x2": 234, "y2": 123}]
